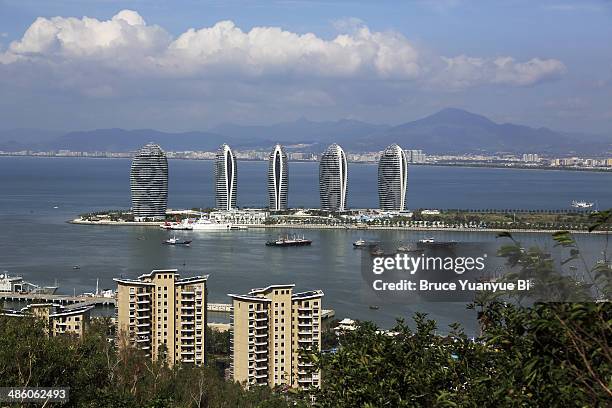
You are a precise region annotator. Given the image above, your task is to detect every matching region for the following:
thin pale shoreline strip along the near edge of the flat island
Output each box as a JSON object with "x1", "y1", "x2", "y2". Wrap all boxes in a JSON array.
[{"x1": 66, "y1": 219, "x2": 610, "y2": 234}]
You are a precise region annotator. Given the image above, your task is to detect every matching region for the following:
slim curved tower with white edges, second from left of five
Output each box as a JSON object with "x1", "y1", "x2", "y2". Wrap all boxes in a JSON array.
[{"x1": 215, "y1": 143, "x2": 238, "y2": 211}]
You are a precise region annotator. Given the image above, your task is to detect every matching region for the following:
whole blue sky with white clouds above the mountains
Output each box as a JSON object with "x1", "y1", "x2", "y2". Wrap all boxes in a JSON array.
[{"x1": 0, "y1": 0, "x2": 612, "y2": 135}]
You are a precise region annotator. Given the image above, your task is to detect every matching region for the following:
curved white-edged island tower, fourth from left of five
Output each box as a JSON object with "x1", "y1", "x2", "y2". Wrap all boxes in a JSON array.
[{"x1": 319, "y1": 143, "x2": 348, "y2": 211}]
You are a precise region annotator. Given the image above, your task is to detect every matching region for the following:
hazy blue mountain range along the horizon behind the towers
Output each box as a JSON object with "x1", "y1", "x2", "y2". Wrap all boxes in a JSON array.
[{"x1": 0, "y1": 108, "x2": 612, "y2": 154}]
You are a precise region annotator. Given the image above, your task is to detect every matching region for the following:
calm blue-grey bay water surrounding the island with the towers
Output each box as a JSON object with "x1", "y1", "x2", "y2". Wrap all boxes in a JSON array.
[{"x1": 0, "y1": 157, "x2": 612, "y2": 332}]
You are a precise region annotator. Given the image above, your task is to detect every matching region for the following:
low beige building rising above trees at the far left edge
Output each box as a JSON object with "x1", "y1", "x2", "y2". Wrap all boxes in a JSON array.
[{"x1": 2, "y1": 303, "x2": 94, "y2": 338}]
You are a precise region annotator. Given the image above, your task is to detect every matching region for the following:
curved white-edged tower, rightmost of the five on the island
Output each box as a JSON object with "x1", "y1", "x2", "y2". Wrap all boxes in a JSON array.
[{"x1": 378, "y1": 144, "x2": 408, "y2": 211}]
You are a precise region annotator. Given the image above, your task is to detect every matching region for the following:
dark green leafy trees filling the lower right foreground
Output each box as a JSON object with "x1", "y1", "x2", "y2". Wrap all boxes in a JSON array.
[{"x1": 315, "y1": 302, "x2": 612, "y2": 407}]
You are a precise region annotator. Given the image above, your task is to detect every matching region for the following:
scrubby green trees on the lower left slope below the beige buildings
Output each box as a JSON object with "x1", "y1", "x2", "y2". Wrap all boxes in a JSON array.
[{"x1": 0, "y1": 316, "x2": 299, "y2": 408}]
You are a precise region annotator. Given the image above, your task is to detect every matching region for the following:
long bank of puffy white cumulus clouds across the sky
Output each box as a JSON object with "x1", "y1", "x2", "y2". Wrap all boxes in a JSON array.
[{"x1": 0, "y1": 10, "x2": 565, "y2": 90}]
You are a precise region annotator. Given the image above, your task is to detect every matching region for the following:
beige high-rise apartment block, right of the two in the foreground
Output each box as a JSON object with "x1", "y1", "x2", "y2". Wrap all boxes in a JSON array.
[{"x1": 229, "y1": 284, "x2": 323, "y2": 389}]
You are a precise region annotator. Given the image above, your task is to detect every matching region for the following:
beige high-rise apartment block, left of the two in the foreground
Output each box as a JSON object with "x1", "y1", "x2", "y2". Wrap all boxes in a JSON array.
[{"x1": 114, "y1": 269, "x2": 208, "y2": 365}]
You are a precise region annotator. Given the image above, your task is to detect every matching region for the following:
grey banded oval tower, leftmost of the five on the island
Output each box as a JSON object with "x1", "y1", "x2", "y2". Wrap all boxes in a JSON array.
[{"x1": 130, "y1": 143, "x2": 168, "y2": 221}]
